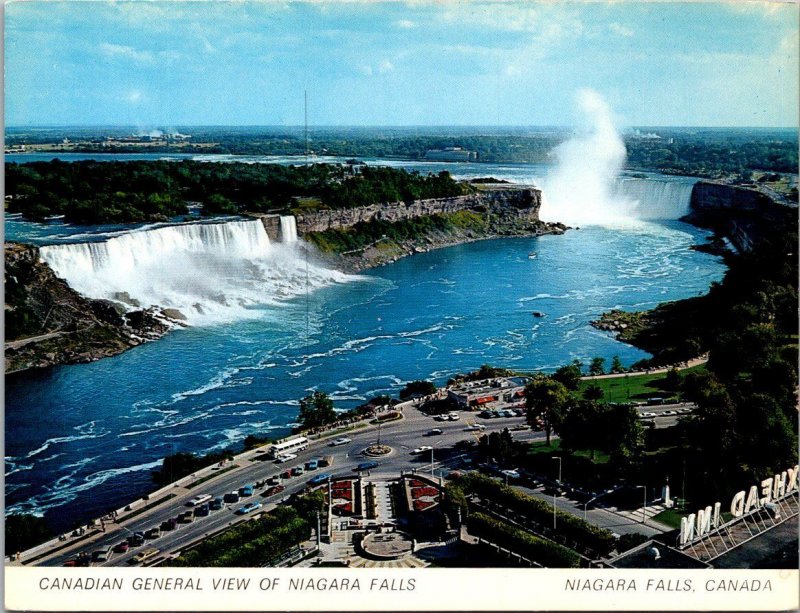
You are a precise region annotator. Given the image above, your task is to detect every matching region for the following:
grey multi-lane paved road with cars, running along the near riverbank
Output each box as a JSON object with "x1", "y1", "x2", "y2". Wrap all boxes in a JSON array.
[{"x1": 31, "y1": 407, "x2": 544, "y2": 566}]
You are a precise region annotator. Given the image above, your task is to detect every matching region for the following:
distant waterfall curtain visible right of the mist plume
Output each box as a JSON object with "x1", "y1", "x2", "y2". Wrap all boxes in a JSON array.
[{"x1": 614, "y1": 177, "x2": 696, "y2": 219}]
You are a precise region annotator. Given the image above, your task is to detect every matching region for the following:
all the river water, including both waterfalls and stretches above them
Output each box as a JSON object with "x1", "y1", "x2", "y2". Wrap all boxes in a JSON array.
[{"x1": 1, "y1": 154, "x2": 725, "y2": 530}]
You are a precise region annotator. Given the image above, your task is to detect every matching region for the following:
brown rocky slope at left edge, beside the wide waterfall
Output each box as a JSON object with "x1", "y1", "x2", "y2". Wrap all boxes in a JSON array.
[{"x1": 5, "y1": 243, "x2": 172, "y2": 373}]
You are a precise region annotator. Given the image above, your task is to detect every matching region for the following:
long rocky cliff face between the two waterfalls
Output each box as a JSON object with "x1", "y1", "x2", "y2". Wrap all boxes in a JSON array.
[{"x1": 284, "y1": 187, "x2": 541, "y2": 234}]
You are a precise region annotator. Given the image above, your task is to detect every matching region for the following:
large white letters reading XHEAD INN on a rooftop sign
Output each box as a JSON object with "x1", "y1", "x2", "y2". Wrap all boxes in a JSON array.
[{"x1": 678, "y1": 464, "x2": 798, "y2": 547}]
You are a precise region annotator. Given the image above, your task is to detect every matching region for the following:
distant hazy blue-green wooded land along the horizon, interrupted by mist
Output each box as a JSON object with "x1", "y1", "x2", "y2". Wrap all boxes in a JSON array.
[{"x1": 7, "y1": 128, "x2": 798, "y2": 177}]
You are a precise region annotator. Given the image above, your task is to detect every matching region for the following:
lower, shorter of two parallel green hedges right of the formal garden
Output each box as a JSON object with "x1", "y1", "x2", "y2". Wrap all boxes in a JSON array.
[{"x1": 467, "y1": 513, "x2": 580, "y2": 568}]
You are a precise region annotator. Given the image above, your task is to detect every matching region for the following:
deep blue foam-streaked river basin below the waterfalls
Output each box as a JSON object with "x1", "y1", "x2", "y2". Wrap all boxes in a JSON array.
[{"x1": 6, "y1": 222, "x2": 724, "y2": 528}]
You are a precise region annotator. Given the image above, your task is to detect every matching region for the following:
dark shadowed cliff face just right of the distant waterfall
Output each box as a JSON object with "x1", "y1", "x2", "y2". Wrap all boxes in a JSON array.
[{"x1": 684, "y1": 181, "x2": 797, "y2": 251}]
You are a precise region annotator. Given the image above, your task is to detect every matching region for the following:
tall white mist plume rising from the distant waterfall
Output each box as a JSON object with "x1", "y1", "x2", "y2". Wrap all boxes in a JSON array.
[{"x1": 540, "y1": 89, "x2": 637, "y2": 225}]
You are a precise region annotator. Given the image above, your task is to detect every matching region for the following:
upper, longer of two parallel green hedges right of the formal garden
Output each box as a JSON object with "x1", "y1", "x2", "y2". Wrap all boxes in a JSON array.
[{"x1": 456, "y1": 473, "x2": 615, "y2": 556}]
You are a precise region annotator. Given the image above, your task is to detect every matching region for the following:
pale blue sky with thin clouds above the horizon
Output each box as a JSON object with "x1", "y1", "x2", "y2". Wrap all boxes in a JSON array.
[{"x1": 4, "y1": 0, "x2": 798, "y2": 128}]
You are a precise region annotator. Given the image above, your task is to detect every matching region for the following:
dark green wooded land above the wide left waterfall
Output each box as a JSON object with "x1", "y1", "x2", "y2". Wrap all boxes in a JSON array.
[{"x1": 6, "y1": 160, "x2": 471, "y2": 224}]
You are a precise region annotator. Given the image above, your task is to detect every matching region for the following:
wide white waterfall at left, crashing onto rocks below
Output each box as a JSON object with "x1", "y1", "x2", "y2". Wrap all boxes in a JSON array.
[{"x1": 40, "y1": 218, "x2": 351, "y2": 324}]
